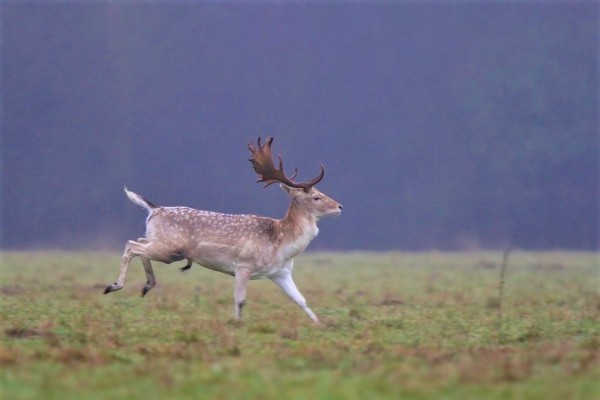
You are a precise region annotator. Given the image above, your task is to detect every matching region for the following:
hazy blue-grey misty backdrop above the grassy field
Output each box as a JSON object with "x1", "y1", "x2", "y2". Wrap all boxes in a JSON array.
[{"x1": 0, "y1": 1, "x2": 600, "y2": 250}]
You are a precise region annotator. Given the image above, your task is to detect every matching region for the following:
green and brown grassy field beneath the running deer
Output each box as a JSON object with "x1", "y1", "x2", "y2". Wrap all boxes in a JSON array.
[{"x1": 0, "y1": 251, "x2": 600, "y2": 400}]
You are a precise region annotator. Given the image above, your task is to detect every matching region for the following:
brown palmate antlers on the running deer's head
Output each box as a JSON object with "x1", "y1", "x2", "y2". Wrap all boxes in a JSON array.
[{"x1": 248, "y1": 137, "x2": 325, "y2": 192}]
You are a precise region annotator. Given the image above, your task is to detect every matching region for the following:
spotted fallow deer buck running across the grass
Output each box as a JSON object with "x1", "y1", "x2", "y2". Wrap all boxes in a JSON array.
[{"x1": 104, "y1": 138, "x2": 342, "y2": 323}]
